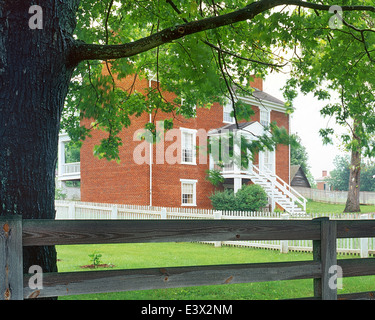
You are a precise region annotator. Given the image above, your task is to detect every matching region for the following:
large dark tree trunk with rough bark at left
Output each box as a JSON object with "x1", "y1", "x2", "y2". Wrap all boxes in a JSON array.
[{"x1": 0, "y1": 0, "x2": 75, "y2": 286}]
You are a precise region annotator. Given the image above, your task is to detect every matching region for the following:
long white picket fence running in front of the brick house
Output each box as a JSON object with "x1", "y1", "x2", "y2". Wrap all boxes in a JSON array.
[{"x1": 55, "y1": 200, "x2": 375, "y2": 257}]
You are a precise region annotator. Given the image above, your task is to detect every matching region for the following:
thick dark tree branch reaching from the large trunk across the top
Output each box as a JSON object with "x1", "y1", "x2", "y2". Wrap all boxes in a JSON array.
[{"x1": 68, "y1": 0, "x2": 375, "y2": 64}]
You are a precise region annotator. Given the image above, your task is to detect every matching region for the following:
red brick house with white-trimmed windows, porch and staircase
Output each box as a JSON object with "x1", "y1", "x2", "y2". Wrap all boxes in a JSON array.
[{"x1": 59, "y1": 77, "x2": 304, "y2": 212}]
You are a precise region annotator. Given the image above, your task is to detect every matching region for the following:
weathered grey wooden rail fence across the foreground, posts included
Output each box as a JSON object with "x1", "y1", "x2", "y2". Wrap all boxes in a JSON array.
[{"x1": 0, "y1": 216, "x2": 375, "y2": 300}]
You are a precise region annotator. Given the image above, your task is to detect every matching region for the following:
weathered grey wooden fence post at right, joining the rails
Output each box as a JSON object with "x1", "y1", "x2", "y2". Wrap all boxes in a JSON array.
[{"x1": 313, "y1": 217, "x2": 339, "y2": 300}]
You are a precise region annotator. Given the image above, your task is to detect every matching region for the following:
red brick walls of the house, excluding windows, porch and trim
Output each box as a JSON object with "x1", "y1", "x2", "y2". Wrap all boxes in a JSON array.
[{"x1": 81, "y1": 77, "x2": 289, "y2": 208}]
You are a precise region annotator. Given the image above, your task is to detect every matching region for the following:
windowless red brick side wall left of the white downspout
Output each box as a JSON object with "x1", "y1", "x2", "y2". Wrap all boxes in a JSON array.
[{"x1": 81, "y1": 77, "x2": 149, "y2": 205}]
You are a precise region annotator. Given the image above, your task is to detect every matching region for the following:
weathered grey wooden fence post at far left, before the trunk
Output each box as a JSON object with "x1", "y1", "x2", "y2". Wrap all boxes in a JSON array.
[{"x1": 0, "y1": 215, "x2": 23, "y2": 300}]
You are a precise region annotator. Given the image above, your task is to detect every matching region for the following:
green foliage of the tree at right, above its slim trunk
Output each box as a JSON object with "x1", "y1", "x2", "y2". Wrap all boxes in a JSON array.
[{"x1": 285, "y1": 1, "x2": 375, "y2": 157}]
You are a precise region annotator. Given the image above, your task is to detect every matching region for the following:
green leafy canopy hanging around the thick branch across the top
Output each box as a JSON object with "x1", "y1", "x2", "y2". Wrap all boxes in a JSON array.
[{"x1": 62, "y1": 0, "x2": 374, "y2": 159}]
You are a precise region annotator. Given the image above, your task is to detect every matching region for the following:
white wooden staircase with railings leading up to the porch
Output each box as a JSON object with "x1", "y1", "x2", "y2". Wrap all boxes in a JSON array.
[{"x1": 247, "y1": 165, "x2": 307, "y2": 215}]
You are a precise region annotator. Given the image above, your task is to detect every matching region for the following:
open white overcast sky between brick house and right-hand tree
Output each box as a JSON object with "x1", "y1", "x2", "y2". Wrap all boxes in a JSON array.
[{"x1": 263, "y1": 73, "x2": 343, "y2": 178}]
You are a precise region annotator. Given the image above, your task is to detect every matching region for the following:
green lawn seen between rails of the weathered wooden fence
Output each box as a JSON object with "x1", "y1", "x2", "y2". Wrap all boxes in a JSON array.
[{"x1": 57, "y1": 243, "x2": 375, "y2": 300}]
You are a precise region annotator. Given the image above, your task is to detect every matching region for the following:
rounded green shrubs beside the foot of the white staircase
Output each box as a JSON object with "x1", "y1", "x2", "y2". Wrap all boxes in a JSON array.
[{"x1": 210, "y1": 184, "x2": 268, "y2": 211}]
